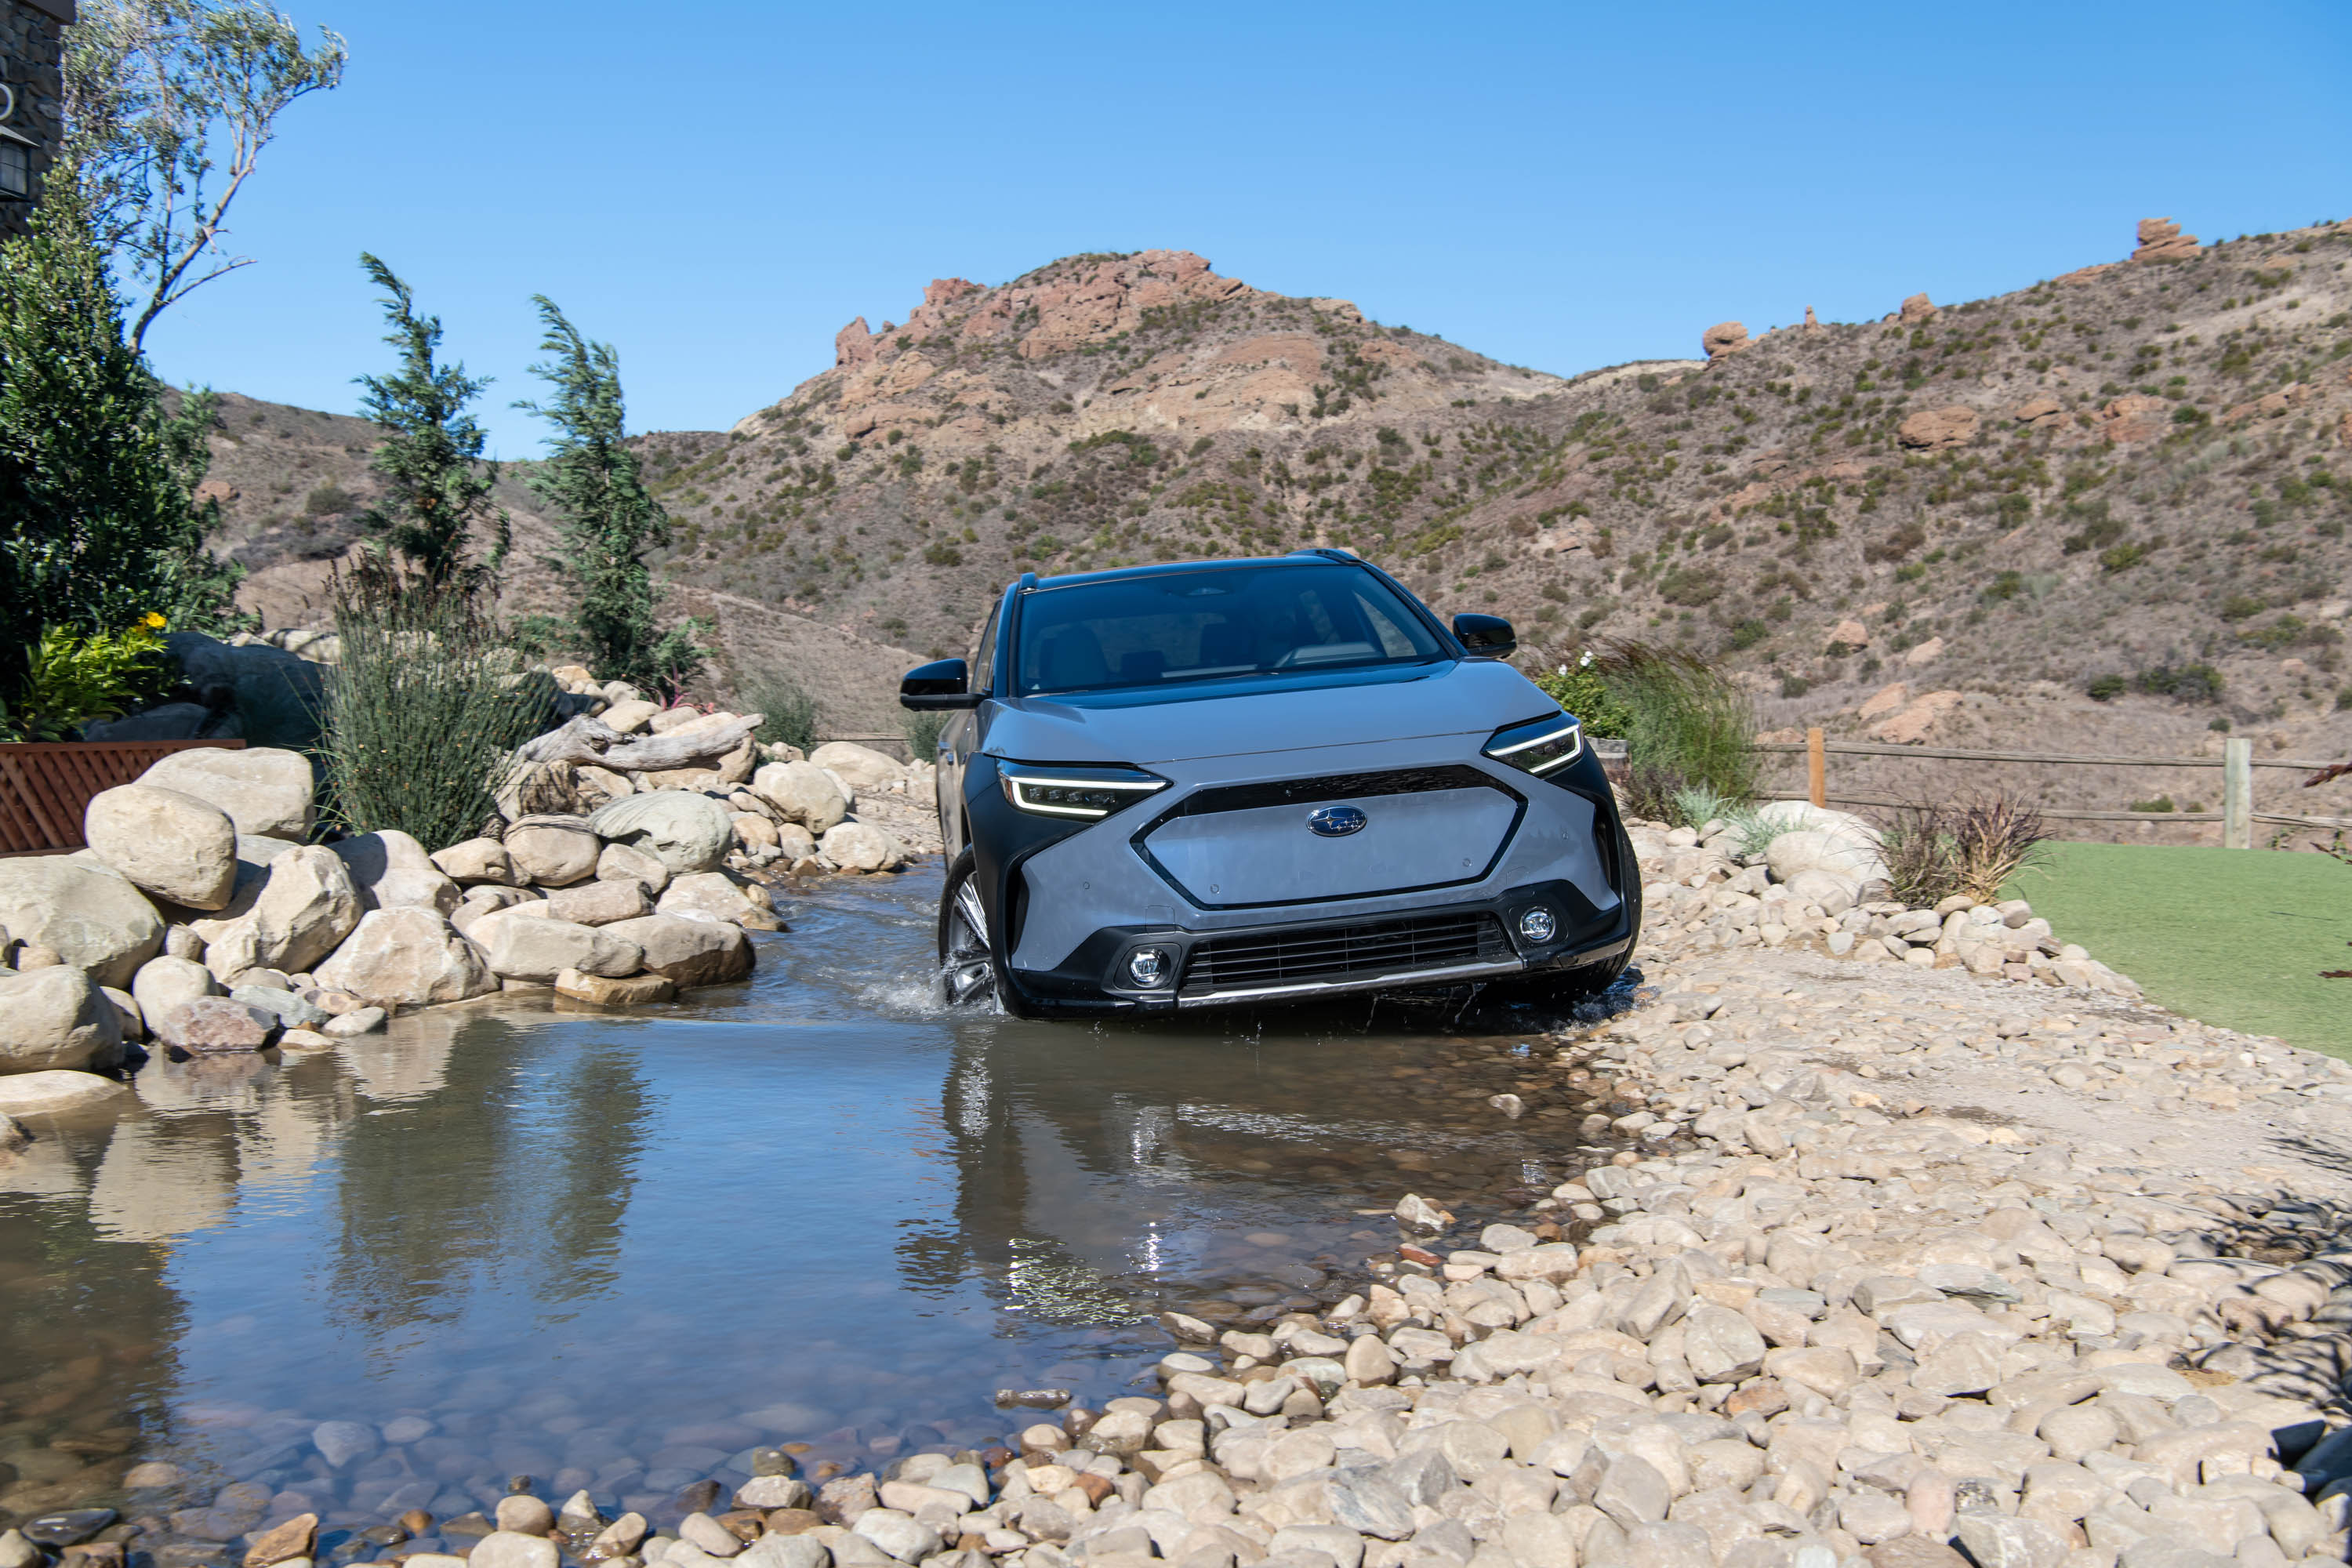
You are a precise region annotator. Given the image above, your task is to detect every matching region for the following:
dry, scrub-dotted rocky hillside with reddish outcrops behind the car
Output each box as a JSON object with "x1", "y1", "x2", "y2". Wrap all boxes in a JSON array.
[{"x1": 198, "y1": 221, "x2": 2352, "y2": 813}]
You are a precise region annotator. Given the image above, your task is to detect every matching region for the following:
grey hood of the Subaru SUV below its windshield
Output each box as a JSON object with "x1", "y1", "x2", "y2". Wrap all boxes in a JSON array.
[{"x1": 983, "y1": 659, "x2": 1552, "y2": 764}]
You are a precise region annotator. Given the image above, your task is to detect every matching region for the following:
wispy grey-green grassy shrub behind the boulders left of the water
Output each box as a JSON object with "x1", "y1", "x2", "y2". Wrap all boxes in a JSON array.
[{"x1": 318, "y1": 573, "x2": 555, "y2": 848}]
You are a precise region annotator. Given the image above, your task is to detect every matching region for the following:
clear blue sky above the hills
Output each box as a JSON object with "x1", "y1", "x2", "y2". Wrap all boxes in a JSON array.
[{"x1": 133, "y1": 0, "x2": 2352, "y2": 456}]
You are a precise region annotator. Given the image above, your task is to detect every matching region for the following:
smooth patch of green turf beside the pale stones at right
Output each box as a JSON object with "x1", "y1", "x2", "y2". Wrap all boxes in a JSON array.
[{"x1": 2009, "y1": 844, "x2": 2352, "y2": 1058}]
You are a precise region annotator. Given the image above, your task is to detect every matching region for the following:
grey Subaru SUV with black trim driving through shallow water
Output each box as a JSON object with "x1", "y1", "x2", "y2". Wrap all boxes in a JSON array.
[{"x1": 898, "y1": 550, "x2": 1642, "y2": 1015}]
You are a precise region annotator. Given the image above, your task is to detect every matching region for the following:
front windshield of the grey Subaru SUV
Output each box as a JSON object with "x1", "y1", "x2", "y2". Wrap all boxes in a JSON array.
[{"x1": 1014, "y1": 562, "x2": 1444, "y2": 696}]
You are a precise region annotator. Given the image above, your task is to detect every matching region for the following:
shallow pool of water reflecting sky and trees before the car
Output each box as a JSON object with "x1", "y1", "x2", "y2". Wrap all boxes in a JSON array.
[{"x1": 0, "y1": 877, "x2": 1618, "y2": 1528}]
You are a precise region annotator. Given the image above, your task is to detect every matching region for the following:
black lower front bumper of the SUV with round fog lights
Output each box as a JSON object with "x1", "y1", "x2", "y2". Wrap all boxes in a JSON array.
[{"x1": 1009, "y1": 881, "x2": 1635, "y2": 1013}]
